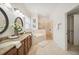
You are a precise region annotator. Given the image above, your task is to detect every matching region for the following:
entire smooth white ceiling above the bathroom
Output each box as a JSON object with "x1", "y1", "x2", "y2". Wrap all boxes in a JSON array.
[{"x1": 12, "y1": 3, "x2": 77, "y2": 16}]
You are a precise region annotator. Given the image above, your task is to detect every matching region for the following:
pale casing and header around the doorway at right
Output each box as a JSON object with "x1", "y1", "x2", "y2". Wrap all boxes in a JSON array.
[{"x1": 65, "y1": 5, "x2": 79, "y2": 50}]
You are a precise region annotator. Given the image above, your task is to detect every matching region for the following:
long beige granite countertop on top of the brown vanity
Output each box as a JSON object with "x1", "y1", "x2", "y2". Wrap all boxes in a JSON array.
[{"x1": 0, "y1": 33, "x2": 31, "y2": 55}]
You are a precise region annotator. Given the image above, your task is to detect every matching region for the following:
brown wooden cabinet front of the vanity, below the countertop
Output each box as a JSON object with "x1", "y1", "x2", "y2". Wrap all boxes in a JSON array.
[{"x1": 4, "y1": 35, "x2": 32, "y2": 55}]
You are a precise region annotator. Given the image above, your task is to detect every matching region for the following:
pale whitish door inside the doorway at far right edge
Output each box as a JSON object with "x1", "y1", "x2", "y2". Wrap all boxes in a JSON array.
[{"x1": 74, "y1": 15, "x2": 79, "y2": 45}]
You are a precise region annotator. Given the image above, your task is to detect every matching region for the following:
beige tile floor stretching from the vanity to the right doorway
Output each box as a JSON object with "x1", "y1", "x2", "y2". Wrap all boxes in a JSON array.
[{"x1": 28, "y1": 40, "x2": 79, "y2": 55}]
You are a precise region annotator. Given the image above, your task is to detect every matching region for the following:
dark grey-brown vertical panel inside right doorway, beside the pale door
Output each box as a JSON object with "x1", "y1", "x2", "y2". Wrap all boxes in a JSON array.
[{"x1": 67, "y1": 14, "x2": 74, "y2": 50}]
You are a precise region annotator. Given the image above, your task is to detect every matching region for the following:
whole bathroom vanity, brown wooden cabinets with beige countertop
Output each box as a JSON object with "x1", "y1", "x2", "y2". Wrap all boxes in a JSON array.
[{"x1": 0, "y1": 33, "x2": 32, "y2": 55}]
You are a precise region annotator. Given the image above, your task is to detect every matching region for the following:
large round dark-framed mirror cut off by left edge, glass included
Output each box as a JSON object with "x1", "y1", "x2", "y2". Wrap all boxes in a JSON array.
[{"x1": 0, "y1": 8, "x2": 9, "y2": 34}]
